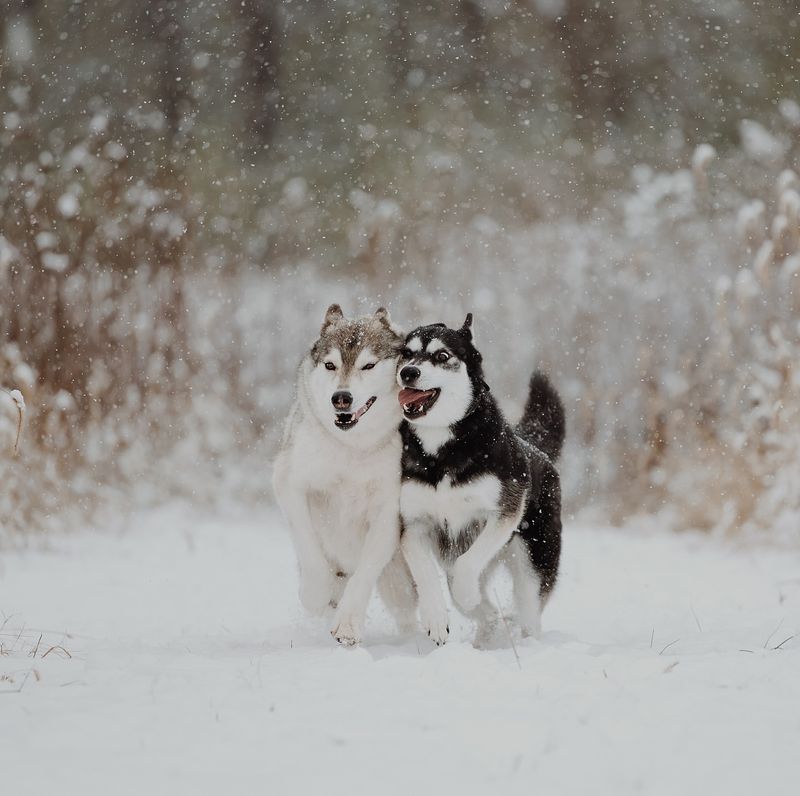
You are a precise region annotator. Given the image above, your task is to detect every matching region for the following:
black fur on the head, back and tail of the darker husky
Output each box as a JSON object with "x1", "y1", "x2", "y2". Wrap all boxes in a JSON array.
[{"x1": 400, "y1": 324, "x2": 564, "y2": 596}]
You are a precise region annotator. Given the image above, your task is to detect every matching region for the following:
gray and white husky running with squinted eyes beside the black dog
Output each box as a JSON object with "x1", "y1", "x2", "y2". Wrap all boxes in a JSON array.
[{"x1": 273, "y1": 304, "x2": 416, "y2": 644}]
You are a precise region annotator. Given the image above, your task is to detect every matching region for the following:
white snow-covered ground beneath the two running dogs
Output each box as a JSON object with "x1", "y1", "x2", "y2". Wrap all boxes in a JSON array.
[{"x1": 0, "y1": 510, "x2": 800, "y2": 796}]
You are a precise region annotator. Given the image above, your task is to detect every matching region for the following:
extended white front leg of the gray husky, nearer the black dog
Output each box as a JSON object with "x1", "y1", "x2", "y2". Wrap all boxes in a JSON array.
[{"x1": 331, "y1": 504, "x2": 400, "y2": 646}]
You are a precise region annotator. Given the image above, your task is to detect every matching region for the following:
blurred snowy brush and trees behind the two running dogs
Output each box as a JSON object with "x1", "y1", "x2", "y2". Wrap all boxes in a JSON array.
[{"x1": 0, "y1": 0, "x2": 800, "y2": 542}]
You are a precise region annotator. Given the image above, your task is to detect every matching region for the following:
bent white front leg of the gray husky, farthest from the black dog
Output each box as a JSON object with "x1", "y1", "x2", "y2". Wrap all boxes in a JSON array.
[{"x1": 274, "y1": 467, "x2": 338, "y2": 616}]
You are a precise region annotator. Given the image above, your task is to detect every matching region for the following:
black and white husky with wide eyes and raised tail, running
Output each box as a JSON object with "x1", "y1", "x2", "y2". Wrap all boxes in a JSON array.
[{"x1": 397, "y1": 315, "x2": 565, "y2": 645}]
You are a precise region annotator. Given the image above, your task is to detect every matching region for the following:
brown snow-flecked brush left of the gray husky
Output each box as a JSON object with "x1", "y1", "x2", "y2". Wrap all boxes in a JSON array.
[{"x1": 0, "y1": 92, "x2": 272, "y2": 535}]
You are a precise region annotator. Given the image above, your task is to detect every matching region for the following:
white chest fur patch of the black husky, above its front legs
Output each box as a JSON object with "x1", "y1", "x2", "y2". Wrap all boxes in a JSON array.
[{"x1": 400, "y1": 475, "x2": 501, "y2": 536}]
